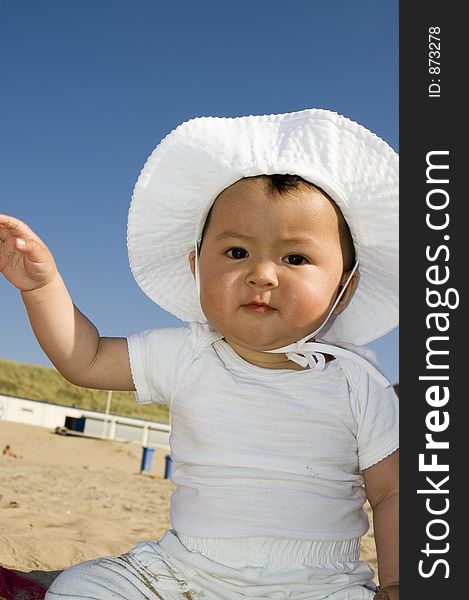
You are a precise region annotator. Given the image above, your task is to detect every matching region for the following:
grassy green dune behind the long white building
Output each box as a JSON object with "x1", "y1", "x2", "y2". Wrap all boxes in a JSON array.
[{"x1": 0, "y1": 359, "x2": 169, "y2": 423}]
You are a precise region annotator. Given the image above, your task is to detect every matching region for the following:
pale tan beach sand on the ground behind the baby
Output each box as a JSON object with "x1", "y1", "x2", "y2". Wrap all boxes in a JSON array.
[{"x1": 0, "y1": 421, "x2": 376, "y2": 583}]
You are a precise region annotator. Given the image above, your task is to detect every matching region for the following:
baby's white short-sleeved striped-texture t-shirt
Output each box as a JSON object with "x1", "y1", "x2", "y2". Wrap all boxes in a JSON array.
[{"x1": 128, "y1": 324, "x2": 399, "y2": 540}]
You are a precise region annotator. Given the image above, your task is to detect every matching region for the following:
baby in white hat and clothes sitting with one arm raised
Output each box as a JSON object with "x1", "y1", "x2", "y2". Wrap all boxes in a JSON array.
[{"x1": 0, "y1": 109, "x2": 399, "y2": 600}]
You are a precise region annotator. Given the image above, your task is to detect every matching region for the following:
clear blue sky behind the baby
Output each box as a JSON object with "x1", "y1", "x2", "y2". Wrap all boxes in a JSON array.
[{"x1": 0, "y1": 0, "x2": 399, "y2": 382}]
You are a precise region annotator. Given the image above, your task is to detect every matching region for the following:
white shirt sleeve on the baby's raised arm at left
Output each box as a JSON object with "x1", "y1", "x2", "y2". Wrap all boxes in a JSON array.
[{"x1": 127, "y1": 327, "x2": 192, "y2": 406}]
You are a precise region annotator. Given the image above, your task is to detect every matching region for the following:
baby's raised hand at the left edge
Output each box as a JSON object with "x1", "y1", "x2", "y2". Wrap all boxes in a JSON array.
[{"x1": 0, "y1": 215, "x2": 57, "y2": 292}]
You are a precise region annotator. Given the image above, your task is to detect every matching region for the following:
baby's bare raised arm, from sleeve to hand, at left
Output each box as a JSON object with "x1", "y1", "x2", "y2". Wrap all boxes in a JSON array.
[{"x1": 0, "y1": 215, "x2": 134, "y2": 390}]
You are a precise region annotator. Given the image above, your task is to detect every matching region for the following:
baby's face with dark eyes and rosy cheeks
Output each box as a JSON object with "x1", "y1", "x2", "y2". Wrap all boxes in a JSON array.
[{"x1": 191, "y1": 179, "x2": 352, "y2": 356}]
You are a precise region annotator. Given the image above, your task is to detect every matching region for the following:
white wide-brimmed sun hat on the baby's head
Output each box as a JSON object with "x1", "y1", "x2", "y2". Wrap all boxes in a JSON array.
[{"x1": 127, "y1": 109, "x2": 399, "y2": 345}]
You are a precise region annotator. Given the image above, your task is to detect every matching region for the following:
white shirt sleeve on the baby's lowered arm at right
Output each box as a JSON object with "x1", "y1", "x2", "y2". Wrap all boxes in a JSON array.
[{"x1": 356, "y1": 371, "x2": 399, "y2": 471}]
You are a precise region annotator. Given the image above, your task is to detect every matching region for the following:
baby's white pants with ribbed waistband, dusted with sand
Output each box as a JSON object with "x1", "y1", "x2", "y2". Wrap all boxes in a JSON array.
[{"x1": 45, "y1": 530, "x2": 375, "y2": 600}]
